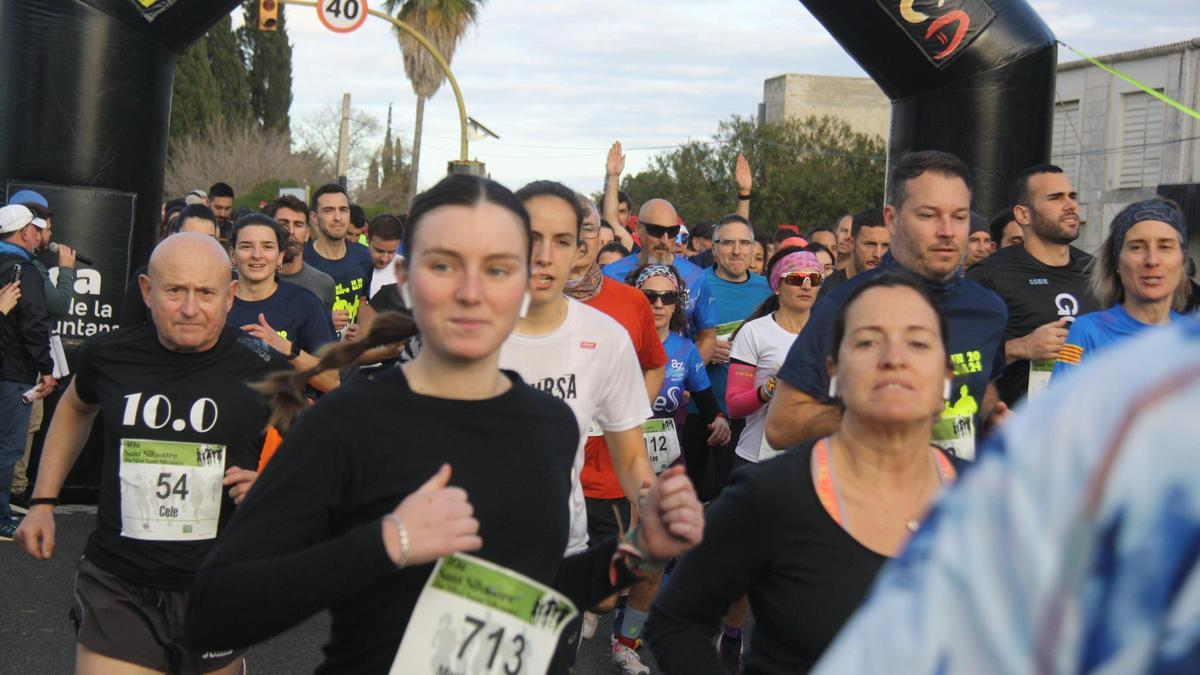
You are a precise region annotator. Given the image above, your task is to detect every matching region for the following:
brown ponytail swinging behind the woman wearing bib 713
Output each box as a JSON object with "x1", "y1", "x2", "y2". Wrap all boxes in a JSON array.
[{"x1": 251, "y1": 312, "x2": 418, "y2": 431}]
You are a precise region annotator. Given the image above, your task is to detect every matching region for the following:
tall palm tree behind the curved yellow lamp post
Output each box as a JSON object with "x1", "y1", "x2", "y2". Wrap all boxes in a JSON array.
[{"x1": 384, "y1": 0, "x2": 484, "y2": 201}]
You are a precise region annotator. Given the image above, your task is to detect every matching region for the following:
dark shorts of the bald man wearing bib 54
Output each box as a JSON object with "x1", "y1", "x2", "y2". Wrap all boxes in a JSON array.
[{"x1": 71, "y1": 557, "x2": 246, "y2": 675}]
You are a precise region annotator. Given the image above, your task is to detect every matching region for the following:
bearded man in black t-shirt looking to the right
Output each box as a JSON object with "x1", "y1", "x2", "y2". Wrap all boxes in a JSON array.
[{"x1": 967, "y1": 165, "x2": 1100, "y2": 407}]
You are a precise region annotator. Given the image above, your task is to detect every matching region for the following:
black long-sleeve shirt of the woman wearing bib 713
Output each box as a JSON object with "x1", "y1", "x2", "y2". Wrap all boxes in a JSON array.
[{"x1": 187, "y1": 369, "x2": 631, "y2": 674}]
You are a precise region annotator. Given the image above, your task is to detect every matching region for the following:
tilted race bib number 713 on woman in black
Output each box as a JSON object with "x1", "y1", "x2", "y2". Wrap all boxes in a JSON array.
[{"x1": 389, "y1": 554, "x2": 578, "y2": 675}]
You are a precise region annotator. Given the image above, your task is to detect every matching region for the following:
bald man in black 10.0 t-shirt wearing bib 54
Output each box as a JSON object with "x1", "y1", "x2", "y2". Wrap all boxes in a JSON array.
[{"x1": 16, "y1": 233, "x2": 290, "y2": 675}]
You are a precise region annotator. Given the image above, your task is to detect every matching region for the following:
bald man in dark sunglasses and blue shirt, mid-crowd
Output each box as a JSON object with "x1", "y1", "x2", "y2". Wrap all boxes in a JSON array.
[{"x1": 604, "y1": 199, "x2": 716, "y2": 363}]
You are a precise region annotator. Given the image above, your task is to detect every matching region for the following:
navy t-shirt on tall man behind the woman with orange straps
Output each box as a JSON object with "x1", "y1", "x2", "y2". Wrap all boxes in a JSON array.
[{"x1": 779, "y1": 253, "x2": 1008, "y2": 460}]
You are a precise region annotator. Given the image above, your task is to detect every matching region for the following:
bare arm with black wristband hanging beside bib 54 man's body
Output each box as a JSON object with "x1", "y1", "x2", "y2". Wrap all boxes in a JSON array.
[{"x1": 17, "y1": 381, "x2": 100, "y2": 560}]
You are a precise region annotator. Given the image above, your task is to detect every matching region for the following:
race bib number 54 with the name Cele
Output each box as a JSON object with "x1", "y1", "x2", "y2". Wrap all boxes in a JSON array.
[{"x1": 120, "y1": 438, "x2": 226, "y2": 542}]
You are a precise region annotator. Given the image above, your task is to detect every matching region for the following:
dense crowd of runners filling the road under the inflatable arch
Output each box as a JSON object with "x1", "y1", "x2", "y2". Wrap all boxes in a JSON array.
[{"x1": 0, "y1": 138, "x2": 1200, "y2": 675}]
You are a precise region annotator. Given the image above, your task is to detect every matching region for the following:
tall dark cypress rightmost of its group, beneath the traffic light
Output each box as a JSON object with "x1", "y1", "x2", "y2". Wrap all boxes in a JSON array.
[{"x1": 238, "y1": 0, "x2": 292, "y2": 135}]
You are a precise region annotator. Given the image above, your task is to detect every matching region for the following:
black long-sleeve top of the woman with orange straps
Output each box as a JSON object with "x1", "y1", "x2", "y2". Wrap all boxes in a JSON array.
[{"x1": 646, "y1": 443, "x2": 887, "y2": 675}]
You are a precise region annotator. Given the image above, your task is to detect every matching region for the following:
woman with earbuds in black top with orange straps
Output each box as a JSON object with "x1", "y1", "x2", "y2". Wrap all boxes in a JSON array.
[{"x1": 646, "y1": 274, "x2": 958, "y2": 675}]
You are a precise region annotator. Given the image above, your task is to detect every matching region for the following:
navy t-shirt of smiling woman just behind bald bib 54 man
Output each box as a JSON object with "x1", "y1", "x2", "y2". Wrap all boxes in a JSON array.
[{"x1": 226, "y1": 281, "x2": 337, "y2": 354}]
